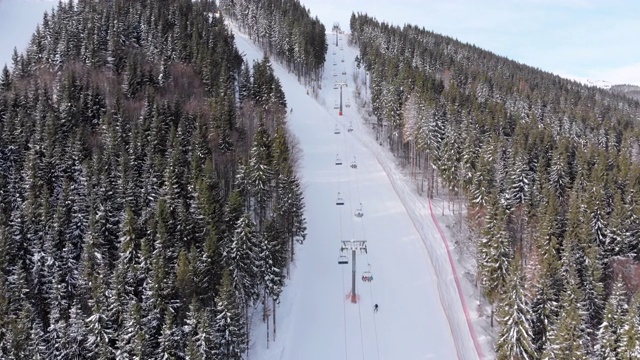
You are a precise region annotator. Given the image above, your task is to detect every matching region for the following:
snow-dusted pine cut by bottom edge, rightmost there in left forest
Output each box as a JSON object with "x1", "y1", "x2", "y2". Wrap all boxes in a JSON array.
[{"x1": 213, "y1": 271, "x2": 247, "y2": 360}]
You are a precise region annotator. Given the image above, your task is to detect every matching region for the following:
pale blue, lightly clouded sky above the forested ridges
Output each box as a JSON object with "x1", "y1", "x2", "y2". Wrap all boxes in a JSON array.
[{"x1": 0, "y1": 0, "x2": 640, "y2": 85}]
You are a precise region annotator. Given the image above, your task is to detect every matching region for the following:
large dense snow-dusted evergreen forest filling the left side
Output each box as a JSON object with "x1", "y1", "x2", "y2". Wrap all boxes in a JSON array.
[{"x1": 0, "y1": 0, "x2": 310, "y2": 360}]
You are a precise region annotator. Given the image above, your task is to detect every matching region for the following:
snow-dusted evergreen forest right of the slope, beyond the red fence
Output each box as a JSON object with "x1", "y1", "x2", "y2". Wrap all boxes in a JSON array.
[{"x1": 350, "y1": 14, "x2": 640, "y2": 359}]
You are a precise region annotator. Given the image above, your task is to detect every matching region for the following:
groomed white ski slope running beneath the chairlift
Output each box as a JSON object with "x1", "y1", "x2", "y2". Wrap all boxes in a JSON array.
[{"x1": 234, "y1": 29, "x2": 479, "y2": 360}]
